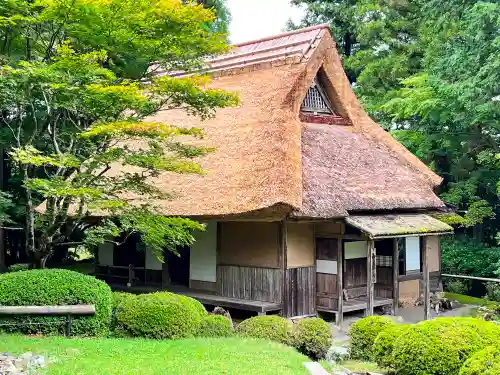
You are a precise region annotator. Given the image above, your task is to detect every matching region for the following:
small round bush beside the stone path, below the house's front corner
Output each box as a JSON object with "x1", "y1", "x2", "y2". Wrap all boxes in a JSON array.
[{"x1": 293, "y1": 318, "x2": 332, "y2": 360}]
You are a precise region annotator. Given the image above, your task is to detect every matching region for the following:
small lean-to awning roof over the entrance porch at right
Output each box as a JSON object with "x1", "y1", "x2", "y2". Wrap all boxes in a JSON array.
[{"x1": 345, "y1": 214, "x2": 453, "y2": 239}]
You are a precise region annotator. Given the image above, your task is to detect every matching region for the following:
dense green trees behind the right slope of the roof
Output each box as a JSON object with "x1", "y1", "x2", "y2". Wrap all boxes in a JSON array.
[{"x1": 294, "y1": 0, "x2": 500, "y2": 244}]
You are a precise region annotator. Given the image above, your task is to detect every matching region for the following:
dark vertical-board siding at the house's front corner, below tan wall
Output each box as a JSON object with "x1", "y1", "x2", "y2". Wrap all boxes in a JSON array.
[{"x1": 283, "y1": 266, "x2": 316, "y2": 317}]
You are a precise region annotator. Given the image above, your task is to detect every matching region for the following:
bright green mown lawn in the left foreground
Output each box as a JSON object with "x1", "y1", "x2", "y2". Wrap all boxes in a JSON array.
[{"x1": 0, "y1": 335, "x2": 310, "y2": 375}]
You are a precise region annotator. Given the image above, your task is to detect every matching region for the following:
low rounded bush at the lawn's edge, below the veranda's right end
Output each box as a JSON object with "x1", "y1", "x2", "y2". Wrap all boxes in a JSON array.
[{"x1": 236, "y1": 315, "x2": 293, "y2": 345}]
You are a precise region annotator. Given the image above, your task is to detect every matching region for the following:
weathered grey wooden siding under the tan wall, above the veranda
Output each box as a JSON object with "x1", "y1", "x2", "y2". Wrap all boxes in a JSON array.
[{"x1": 217, "y1": 265, "x2": 283, "y2": 303}]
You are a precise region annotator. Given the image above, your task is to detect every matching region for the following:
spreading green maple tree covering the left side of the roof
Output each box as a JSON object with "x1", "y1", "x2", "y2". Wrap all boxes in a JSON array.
[{"x1": 0, "y1": 0, "x2": 237, "y2": 267}]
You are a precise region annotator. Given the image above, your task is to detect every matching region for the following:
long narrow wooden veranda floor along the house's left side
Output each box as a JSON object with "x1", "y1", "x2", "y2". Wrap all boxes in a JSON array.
[{"x1": 110, "y1": 284, "x2": 282, "y2": 315}]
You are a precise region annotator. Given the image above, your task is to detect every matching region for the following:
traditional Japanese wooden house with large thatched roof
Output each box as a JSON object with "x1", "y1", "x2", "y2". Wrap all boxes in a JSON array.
[{"x1": 99, "y1": 25, "x2": 452, "y2": 321}]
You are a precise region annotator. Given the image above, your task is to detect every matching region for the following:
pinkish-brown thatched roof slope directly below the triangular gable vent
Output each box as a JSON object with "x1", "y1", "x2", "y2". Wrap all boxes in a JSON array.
[{"x1": 298, "y1": 123, "x2": 445, "y2": 218}]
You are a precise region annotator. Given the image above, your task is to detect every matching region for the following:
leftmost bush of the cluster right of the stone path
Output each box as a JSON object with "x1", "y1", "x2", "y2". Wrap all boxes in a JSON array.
[{"x1": 349, "y1": 316, "x2": 396, "y2": 361}]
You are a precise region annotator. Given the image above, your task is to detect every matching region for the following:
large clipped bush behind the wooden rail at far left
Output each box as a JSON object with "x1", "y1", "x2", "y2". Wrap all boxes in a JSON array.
[{"x1": 0, "y1": 269, "x2": 112, "y2": 336}]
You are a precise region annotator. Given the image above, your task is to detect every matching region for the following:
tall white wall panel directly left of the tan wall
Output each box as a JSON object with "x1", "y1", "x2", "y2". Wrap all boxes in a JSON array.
[{"x1": 189, "y1": 221, "x2": 217, "y2": 282}]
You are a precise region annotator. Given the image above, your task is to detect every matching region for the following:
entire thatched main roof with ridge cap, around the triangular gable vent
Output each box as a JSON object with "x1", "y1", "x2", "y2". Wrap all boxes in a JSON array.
[{"x1": 98, "y1": 25, "x2": 443, "y2": 217}]
